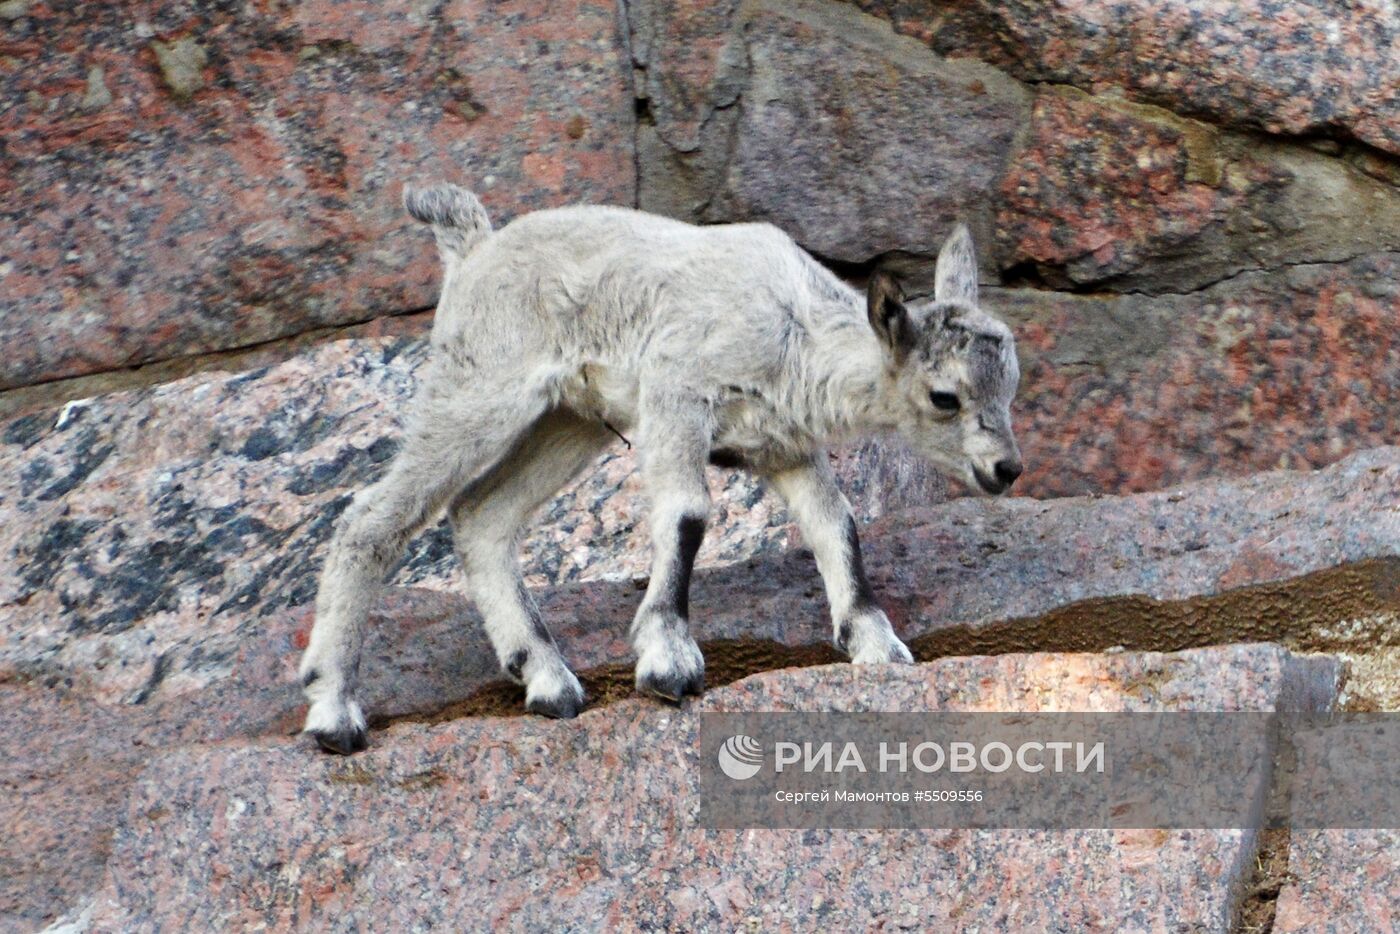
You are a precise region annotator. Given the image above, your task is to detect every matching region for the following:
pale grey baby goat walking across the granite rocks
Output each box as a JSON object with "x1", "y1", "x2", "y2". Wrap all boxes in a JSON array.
[{"x1": 301, "y1": 185, "x2": 1021, "y2": 753}]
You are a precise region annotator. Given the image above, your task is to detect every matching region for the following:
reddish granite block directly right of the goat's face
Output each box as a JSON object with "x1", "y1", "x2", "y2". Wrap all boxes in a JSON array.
[{"x1": 1002, "y1": 252, "x2": 1400, "y2": 496}]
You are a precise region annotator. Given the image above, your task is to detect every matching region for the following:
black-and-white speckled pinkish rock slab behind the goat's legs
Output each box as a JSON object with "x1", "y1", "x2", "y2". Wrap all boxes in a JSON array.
[{"x1": 0, "y1": 337, "x2": 942, "y2": 702}]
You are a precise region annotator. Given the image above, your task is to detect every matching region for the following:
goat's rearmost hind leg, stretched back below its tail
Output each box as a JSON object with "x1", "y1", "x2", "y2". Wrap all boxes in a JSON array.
[{"x1": 300, "y1": 374, "x2": 546, "y2": 755}]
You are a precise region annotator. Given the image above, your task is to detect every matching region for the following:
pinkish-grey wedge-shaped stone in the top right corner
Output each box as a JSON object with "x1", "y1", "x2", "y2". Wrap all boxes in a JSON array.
[{"x1": 860, "y1": 0, "x2": 1400, "y2": 153}]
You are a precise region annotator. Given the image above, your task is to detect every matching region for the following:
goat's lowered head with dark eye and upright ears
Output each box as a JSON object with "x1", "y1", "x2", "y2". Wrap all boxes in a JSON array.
[{"x1": 868, "y1": 224, "x2": 1021, "y2": 493}]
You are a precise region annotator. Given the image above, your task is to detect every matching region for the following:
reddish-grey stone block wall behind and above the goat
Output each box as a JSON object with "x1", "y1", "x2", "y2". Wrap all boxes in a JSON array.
[{"x1": 0, "y1": 0, "x2": 1400, "y2": 496}]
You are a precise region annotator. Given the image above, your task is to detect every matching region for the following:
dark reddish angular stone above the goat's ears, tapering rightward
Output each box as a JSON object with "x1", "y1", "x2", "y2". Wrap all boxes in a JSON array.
[{"x1": 988, "y1": 88, "x2": 1400, "y2": 293}]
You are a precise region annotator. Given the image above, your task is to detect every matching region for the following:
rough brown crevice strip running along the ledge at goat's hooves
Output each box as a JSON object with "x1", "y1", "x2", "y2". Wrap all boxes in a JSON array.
[{"x1": 371, "y1": 557, "x2": 1400, "y2": 730}]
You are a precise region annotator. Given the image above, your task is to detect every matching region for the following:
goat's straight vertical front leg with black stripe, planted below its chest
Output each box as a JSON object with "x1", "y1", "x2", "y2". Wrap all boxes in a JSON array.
[{"x1": 631, "y1": 391, "x2": 710, "y2": 702}]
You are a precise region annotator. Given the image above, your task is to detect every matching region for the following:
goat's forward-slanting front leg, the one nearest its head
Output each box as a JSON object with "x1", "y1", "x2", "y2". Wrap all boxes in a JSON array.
[{"x1": 767, "y1": 451, "x2": 914, "y2": 664}]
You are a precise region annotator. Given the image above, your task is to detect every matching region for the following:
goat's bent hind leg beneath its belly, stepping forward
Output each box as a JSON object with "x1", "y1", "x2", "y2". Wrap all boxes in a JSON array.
[{"x1": 448, "y1": 410, "x2": 609, "y2": 717}]
